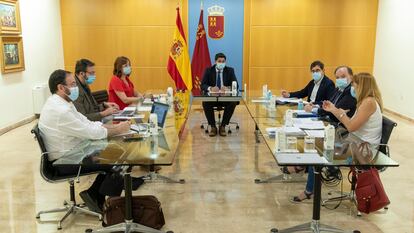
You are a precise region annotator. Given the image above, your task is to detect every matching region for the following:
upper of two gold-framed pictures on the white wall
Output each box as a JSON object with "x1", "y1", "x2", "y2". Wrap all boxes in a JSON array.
[{"x1": 0, "y1": 0, "x2": 21, "y2": 34}]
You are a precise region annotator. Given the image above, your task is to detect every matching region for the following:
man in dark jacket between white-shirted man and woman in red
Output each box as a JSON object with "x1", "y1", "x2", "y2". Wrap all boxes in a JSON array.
[{"x1": 73, "y1": 59, "x2": 119, "y2": 121}]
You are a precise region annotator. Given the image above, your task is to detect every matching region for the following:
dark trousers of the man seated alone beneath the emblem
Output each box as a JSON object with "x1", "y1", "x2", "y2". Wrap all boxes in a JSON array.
[{"x1": 203, "y1": 102, "x2": 238, "y2": 127}]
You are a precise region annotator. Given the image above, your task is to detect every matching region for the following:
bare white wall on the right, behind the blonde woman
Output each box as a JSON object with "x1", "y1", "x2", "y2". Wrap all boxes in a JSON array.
[{"x1": 374, "y1": 0, "x2": 414, "y2": 119}]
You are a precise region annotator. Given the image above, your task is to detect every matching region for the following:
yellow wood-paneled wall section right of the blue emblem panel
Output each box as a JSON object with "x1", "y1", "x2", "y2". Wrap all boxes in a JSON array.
[{"x1": 243, "y1": 0, "x2": 378, "y2": 92}]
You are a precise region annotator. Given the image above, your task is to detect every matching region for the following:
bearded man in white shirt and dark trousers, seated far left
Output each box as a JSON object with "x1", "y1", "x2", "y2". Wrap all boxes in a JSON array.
[{"x1": 39, "y1": 70, "x2": 130, "y2": 212}]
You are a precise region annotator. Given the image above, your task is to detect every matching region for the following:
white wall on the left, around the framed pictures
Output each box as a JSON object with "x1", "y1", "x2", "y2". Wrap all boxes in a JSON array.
[{"x1": 0, "y1": 0, "x2": 64, "y2": 129}]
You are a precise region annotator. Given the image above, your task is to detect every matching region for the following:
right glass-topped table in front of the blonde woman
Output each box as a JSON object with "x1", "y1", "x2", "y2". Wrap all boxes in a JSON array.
[{"x1": 244, "y1": 96, "x2": 399, "y2": 233}]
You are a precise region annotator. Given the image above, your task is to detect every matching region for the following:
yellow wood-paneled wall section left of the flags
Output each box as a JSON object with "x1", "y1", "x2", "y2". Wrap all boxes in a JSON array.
[{"x1": 60, "y1": 0, "x2": 188, "y2": 91}]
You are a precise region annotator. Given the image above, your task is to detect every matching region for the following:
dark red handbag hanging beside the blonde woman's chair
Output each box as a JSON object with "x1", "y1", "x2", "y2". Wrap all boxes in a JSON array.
[{"x1": 355, "y1": 168, "x2": 390, "y2": 214}]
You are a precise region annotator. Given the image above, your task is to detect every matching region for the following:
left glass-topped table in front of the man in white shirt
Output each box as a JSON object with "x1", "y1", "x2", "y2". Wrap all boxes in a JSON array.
[{"x1": 53, "y1": 104, "x2": 180, "y2": 233}]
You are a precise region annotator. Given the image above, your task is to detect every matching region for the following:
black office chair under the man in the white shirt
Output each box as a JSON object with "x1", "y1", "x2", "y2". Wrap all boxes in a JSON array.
[{"x1": 31, "y1": 124, "x2": 102, "y2": 230}]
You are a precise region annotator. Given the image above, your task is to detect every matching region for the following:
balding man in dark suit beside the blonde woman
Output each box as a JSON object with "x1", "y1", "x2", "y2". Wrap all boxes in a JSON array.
[{"x1": 305, "y1": 66, "x2": 356, "y2": 122}]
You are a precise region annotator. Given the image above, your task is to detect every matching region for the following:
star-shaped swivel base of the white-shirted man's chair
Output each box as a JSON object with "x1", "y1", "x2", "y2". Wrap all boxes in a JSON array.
[{"x1": 36, "y1": 181, "x2": 102, "y2": 230}]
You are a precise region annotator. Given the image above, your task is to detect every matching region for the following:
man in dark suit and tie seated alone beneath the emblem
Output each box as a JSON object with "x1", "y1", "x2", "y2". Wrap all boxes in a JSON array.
[{"x1": 201, "y1": 53, "x2": 238, "y2": 137}]
